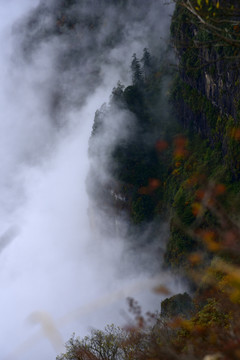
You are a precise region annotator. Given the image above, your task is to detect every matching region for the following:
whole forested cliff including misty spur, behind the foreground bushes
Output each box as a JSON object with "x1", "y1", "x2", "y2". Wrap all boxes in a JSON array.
[{"x1": 88, "y1": 0, "x2": 240, "y2": 268}]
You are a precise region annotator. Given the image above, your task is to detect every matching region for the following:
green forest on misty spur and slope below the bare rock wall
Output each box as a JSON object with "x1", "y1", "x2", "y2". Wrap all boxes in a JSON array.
[{"x1": 90, "y1": 35, "x2": 240, "y2": 262}]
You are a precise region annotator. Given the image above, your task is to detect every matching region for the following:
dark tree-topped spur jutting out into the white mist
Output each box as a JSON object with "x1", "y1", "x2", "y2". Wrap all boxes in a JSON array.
[{"x1": 89, "y1": 49, "x2": 176, "y2": 224}]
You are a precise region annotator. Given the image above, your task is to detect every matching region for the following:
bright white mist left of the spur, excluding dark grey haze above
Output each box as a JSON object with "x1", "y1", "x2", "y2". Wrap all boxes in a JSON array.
[{"x1": 0, "y1": 0, "x2": 181, "y2": 360}]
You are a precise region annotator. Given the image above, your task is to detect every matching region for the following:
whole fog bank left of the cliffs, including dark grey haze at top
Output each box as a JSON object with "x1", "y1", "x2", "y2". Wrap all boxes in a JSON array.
[{"x1": 0, "y1": 0, "x2": 180, "y2": 360}]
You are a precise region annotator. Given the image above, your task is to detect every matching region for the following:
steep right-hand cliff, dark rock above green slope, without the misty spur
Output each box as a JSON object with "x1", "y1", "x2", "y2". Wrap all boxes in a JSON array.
[{"x1": 161, "y1": 0, "x2": 240, "y2": 267}]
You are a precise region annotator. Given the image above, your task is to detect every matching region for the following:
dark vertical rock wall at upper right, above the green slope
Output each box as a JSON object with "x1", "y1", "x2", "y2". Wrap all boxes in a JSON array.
[{"x1": 171, "y1": 0, "x2": 240, "y2": 179}]
